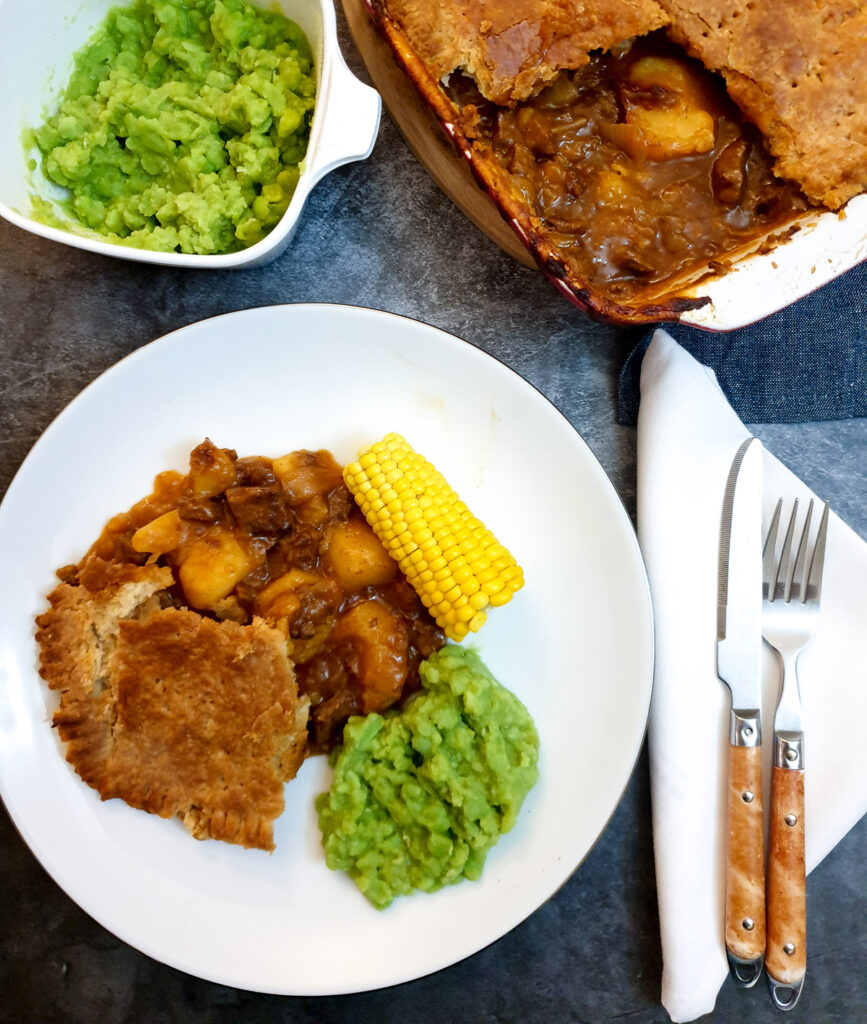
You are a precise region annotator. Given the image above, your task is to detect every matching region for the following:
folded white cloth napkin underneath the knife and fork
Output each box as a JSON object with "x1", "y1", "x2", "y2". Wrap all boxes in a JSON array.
[{"x1": 638, "y1": 331, "x2": 867, "y2": 1022}]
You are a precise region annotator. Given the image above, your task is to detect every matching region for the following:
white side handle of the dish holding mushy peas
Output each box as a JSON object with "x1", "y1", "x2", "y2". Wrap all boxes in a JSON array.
[{"x1": 310, "y1": 54, "x2": 382, "y2": 183}]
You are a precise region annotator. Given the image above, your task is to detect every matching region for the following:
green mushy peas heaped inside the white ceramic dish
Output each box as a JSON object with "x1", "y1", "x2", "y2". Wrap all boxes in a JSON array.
[{"x1": 33, "y1": 0, "x2": 315, "y2": 254}]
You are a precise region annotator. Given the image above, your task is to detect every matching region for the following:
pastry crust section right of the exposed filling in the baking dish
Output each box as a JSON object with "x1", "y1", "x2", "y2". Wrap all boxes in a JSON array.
[{"x1": 659, "y1": 0, "x2": 867, "y2": 210}]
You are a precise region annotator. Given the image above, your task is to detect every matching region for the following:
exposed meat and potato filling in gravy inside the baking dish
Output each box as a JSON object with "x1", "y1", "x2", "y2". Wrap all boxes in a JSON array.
[{"x1": 448, "y1": 33, "x2": 810, "y2": 301}]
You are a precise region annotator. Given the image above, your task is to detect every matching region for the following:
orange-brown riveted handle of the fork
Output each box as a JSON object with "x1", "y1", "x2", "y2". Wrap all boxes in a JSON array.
[{"x1": 767, "y1": 764, "x2": 807, "y2": 1009}]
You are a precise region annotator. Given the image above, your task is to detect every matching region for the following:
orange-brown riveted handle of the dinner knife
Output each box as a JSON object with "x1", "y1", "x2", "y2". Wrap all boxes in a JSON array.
[{"x1": 726, "y1": 744, "x2": 765, "y2": 966}]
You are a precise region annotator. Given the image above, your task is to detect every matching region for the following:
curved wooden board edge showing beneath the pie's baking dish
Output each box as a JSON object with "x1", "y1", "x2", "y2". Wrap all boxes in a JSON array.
[{"x1": 342, "y1": 0, "x2": 536, "y2": 268}]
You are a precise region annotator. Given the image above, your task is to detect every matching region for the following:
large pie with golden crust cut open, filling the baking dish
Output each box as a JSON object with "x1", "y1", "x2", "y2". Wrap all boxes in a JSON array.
[{"x1": 364, "y1": 0, "x2": 867, "y2": 324}]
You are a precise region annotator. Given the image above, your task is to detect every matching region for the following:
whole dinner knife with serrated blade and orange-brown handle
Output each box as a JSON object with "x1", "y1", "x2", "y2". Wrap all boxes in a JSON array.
[{"x1": 717, "y1": 437, "x2": 765, "y2": 988}]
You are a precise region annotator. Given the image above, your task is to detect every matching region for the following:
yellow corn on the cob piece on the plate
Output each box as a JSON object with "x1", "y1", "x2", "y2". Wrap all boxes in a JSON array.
[{"x1": 343, "y1": 433, "x2": 524, "y2": 641}]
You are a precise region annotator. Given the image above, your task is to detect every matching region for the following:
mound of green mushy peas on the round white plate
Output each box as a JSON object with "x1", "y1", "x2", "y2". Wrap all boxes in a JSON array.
[{"x1": 316, "y1": 644, "x2": 538, "y2": 909}]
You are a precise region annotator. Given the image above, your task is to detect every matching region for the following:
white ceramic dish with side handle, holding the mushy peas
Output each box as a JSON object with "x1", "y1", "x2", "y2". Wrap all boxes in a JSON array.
[{"x1": 0, "y1": 0, "x2": 381, "y2": 269}]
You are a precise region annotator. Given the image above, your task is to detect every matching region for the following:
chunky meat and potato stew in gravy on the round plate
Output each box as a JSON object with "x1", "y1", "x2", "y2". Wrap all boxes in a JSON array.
[{"x1": 67, "y1": 440, "x2": 445, "y2": 753}]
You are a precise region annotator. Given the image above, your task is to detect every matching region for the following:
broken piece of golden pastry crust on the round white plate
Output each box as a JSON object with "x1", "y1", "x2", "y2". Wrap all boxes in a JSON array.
[{"x1": 37, "y1": 559, "x2": 307, "y2": 850}]
